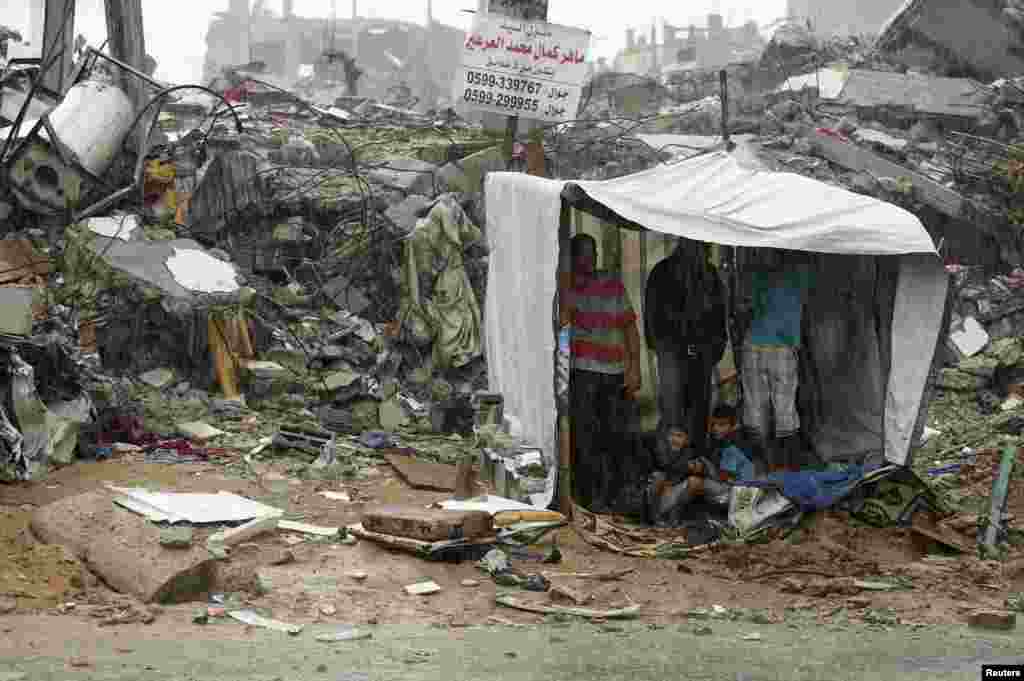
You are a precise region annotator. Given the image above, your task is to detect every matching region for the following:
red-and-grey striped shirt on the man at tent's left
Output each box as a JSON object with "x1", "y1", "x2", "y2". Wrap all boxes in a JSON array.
[{"x1": 569, "y1": 273, "x2": 637, "y2": 375}]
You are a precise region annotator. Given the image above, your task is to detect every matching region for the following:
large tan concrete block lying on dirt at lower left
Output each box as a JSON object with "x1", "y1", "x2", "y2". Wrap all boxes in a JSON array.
[{"x1": 31, "y1": 492, "x2": 217, "y2": 603}]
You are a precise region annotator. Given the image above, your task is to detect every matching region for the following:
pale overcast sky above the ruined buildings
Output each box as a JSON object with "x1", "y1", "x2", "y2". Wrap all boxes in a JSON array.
[{"x1": 9, "y1": 0, "x2": 782, "y2": 83}]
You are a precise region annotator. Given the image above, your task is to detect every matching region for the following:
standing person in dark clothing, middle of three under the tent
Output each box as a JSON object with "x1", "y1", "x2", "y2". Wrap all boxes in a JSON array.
[{"x1": 643, "y1": 239, "x2": 728, "y2": 452}]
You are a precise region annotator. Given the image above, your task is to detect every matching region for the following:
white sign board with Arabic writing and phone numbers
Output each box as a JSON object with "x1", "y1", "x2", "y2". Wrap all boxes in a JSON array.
[{"x1": 455, "y1": 16, "x2": 590, "y2": 123}]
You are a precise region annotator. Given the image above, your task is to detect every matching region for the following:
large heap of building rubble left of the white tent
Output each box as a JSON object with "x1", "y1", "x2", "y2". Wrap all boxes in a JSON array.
[{"x1": 0, "y1": 50, "x2": 520, "y2": 479}]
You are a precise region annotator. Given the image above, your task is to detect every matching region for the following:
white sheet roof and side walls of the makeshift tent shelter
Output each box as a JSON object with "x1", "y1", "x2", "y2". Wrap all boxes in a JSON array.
[{"x1": 485, "y1": 144, "x2": 949, "y2": 507}]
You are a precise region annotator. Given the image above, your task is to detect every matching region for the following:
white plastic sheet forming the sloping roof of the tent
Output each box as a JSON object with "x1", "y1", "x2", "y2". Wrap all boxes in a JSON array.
[{"x1": 565, "y1": 145, "x2": 938, "y2": 257}]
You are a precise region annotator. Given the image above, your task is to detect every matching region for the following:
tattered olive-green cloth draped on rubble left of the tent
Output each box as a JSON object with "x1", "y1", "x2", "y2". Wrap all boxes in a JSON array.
[{"x1": 400, "y1": 195, "x2": 482, "y2": 369}]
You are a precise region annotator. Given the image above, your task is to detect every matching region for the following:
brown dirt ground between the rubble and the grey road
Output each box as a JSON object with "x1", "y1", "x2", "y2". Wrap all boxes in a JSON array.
[{"x1": 0, "y1": 446, "x2": 1024, "y2": 638}]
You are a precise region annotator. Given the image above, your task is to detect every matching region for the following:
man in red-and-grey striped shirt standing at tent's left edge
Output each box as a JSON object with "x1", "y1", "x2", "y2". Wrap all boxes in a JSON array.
[{"x1": 566, "y1": 235, "x2": 640, "y2": 512}]
